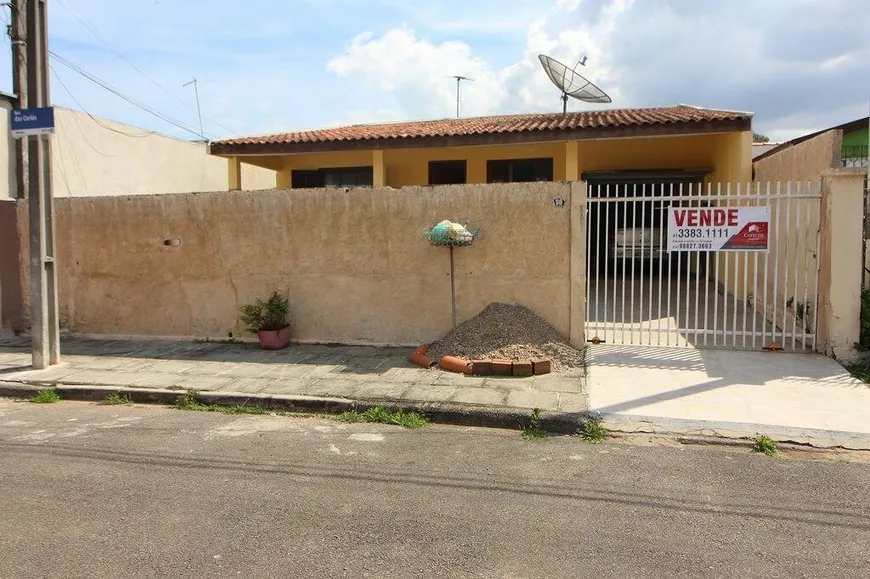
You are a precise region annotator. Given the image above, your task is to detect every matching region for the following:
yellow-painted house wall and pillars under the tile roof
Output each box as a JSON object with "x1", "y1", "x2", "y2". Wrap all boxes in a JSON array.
[{"x1": 270, "y1": 131, "x2": 752, "y2": 188}]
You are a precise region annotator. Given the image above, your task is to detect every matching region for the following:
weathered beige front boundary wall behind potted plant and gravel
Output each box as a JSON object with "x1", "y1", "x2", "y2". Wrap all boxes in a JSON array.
[{"x1": 20, "y1": 183, "x2": 585, "y2": 344}]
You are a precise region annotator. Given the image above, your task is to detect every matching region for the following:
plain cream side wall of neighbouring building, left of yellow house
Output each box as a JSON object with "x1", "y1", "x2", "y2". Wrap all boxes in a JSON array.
[{"x1": 51, "y1": 107, "x2": 275, "y2": 197}]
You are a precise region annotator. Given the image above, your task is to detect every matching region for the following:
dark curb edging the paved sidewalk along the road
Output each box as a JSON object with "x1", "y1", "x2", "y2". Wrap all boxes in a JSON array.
[{"x1": 0, "y1": 382, "x2": 588, "y2": 434}]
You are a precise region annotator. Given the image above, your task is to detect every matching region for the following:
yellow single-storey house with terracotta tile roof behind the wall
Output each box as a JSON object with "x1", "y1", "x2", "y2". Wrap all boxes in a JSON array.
[{"x1": 211, "y1": 105, "x2": 752, "y2": 190}]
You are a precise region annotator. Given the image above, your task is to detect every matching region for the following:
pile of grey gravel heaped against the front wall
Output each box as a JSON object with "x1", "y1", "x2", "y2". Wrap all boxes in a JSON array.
[{"x1": 427, "y1": 303, "x2": 583, "y2": 372}]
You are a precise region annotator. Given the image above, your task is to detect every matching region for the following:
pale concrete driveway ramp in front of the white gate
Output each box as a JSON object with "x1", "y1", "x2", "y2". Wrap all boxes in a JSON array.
[{"x1": 587, "y1": 345, "x2": 870, "y2": 449}]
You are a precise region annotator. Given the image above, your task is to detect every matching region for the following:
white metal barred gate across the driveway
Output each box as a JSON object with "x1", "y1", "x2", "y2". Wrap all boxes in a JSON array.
[{"x1": 586, "y1": 181, "x2": 821, "y2": 351}]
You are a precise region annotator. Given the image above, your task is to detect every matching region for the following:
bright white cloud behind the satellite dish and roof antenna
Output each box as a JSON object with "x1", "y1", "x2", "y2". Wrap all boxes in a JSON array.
[{"x1": 327, "y1": 1, "x2": 630, "y2": 118}]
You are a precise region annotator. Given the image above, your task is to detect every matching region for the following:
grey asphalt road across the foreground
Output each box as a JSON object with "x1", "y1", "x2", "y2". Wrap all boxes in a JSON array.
[{"x1": 0, "y1": 401, "x2": 870, "y2": 579}]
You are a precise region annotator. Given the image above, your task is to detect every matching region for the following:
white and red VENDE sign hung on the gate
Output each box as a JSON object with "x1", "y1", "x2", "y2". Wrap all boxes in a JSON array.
[{"x1": 668, "y1": 206, "x2": 770, "y2": 251}]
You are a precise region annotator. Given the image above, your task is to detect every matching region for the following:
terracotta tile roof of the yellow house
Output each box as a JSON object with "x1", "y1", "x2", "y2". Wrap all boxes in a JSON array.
[{"x1": 212, "y1": 105, "x2": 752, "y2": 154}]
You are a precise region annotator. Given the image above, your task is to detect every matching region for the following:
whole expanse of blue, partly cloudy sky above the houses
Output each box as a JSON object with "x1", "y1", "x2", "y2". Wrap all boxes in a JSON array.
[{"x1": 0, "y1": 0, "x2": 870, "y2": 139}]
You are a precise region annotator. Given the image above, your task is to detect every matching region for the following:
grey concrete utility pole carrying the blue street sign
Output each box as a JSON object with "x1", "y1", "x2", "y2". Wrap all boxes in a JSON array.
[{"x1": 25, "y1": 0, "x2": 60, "y2": 369}]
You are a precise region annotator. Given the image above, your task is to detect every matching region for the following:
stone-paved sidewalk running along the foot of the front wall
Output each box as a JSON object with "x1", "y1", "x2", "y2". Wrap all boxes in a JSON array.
[{"x1": 0, "y1": 336, "x2": 587, "y2": 422}]
